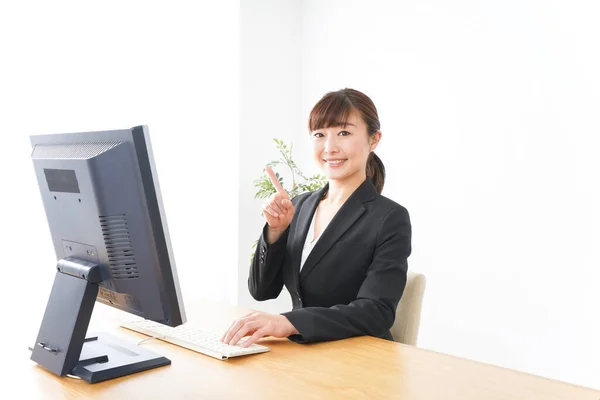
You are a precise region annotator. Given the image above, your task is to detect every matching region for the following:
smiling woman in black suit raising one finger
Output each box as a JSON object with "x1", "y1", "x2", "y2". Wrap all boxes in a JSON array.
[{"x1": 221, "y1": 89, "x2": 411, "y2": 346}]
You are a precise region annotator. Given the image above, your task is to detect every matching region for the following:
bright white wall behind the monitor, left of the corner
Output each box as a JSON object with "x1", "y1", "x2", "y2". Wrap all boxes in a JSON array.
[{"x1": 0, "y1": 0, "x2": 239, "y2": 340}]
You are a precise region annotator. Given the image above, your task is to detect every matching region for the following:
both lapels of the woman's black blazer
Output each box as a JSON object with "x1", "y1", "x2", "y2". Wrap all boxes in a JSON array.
[{"x1": 295, "y1": 178, "x2": 377, "y2": 281}]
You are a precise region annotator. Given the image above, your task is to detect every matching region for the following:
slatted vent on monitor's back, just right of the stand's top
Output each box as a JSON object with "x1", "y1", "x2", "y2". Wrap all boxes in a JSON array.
[{"x1": 100, "y1": 214, "x2": 139, "y2": 280}]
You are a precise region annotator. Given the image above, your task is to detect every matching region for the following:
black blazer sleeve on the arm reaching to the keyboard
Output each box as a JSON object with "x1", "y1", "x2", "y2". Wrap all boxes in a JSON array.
[{"x1": 282, "y1": 207, "x2": 411, "y2": 343}]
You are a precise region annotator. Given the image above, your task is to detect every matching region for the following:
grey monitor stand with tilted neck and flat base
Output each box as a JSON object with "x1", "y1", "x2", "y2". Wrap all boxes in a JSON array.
[{"x1": 30, "y1": 258, "x2": 171, "y2": 383}]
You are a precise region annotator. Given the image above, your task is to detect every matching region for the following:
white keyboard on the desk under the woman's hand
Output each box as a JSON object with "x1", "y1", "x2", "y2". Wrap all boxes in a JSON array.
[{"x1": 120, "y1": 320, "x2": 269, "y2": 360}]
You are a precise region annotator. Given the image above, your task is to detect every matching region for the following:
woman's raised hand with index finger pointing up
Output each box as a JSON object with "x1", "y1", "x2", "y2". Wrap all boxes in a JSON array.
[{"x1": 262, "y1": 166, "x2": 294, "y2": 244}]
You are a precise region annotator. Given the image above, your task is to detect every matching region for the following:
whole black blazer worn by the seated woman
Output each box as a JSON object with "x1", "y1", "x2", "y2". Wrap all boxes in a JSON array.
[{"x1": 248, "y1": 179, "x2": 411, "y2": 343}]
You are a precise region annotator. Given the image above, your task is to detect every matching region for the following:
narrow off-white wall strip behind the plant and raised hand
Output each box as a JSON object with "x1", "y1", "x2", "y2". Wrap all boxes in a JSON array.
[{"x1": 238, "y1": 0, "x2": 306, "y2": 312}]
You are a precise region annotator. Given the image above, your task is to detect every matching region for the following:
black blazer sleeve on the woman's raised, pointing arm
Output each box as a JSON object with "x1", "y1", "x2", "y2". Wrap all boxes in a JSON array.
[{"x1": 248, "y1": 196, "x2": 300, "y2": 301}]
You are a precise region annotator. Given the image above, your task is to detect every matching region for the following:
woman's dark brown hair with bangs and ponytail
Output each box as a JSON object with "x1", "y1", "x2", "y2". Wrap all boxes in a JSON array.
[{"x1": 308, "y1": 88, "x2": 385, "y2": 193}]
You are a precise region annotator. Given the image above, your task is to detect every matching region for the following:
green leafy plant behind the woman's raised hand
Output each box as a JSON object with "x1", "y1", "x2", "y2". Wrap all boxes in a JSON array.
[{"x1": 250, "y1": 139, "x2": 327, "y2": 261}]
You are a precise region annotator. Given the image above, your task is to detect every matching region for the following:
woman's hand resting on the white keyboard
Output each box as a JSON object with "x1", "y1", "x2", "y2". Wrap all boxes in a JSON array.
[{"x1": 221, "y1": 312, "x2": 298, "y2": 347}]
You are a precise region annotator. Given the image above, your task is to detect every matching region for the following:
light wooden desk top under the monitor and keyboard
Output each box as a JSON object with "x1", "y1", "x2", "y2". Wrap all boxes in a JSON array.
[{"x1": 10, "y1": 301, "x2": 600, "y2": 400}]
